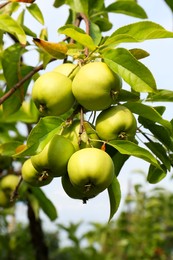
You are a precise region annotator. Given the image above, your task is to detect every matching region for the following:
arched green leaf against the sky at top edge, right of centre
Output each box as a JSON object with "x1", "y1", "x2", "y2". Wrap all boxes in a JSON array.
[{"x1": 106, "y1": 1, "x2": 147, "y2": 19}]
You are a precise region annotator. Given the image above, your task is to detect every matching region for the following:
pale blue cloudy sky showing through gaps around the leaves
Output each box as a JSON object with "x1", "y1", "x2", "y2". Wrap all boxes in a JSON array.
[{"x1": 14, "y1": 0, "x2": 173, "y2": 232}]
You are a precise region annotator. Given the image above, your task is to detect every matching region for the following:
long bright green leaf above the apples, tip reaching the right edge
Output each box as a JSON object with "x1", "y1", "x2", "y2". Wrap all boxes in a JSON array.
[{"x1": 103, "y1": 21, "x2": 173, "y2": 46}]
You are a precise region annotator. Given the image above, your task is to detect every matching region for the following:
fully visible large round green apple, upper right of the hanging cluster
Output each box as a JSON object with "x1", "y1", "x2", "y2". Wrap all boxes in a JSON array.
[{"x1": 72, "y1": 62, "x2": 122, "y2": 111}]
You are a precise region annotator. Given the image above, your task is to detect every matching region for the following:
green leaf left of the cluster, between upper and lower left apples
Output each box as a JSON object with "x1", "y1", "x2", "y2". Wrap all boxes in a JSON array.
[{"x1": 14, "y1": 116, "x2": 64, "y2": 157}]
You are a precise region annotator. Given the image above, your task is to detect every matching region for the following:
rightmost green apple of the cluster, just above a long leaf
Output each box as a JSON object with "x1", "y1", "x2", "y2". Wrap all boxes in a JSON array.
[{"x1": 96, "y1": 105, "x2": 137, "y2": 141}]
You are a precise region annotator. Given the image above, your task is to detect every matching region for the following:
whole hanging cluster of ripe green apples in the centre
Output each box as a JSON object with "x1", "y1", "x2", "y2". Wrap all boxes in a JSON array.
[{"x1": 22, "y1": 61, "x2": 137, "y2": 202}]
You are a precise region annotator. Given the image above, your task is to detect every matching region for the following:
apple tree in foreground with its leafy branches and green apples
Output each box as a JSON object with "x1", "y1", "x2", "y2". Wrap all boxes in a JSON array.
[{"x1": 0, "y1": 0, "x2": 173, "y2": 246}]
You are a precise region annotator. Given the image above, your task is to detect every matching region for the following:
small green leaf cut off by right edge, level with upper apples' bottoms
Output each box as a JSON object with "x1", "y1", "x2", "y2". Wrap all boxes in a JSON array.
[{"x1": 147, "y1": 89, "x2": 173, "y2": 102}]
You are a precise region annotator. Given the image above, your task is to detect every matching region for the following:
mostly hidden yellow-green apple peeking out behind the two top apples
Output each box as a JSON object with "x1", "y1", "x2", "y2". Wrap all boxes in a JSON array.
[{"x1": 53, "y1": 63, "x2": 79, "y2": 80}]
